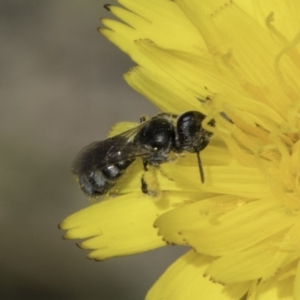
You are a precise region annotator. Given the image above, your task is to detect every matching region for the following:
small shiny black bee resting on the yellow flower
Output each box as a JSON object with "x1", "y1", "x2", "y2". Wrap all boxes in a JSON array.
[{"x1": 71, "y1": 111, "x2": 215, "y2": 197}]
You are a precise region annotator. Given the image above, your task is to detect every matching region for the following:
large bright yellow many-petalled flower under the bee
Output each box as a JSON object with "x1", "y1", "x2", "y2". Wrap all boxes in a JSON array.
[{"x1": 61, "y1": 0, "x2": 300, "y2": 300}]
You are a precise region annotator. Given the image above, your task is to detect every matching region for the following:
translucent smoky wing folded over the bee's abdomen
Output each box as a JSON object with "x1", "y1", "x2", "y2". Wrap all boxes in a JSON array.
[{"x1": 71, "y1": 123, "x2": 152, "y2": 174}]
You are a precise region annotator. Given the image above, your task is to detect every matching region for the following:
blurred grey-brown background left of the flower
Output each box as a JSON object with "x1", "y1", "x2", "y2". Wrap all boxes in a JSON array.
[{"x1": 0, "y1": 0, "x2": 184, "y2": 300}]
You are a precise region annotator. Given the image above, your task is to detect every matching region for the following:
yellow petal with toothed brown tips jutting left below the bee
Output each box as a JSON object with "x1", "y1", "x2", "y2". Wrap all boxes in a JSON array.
[{"x1": 60, "y1": 193, "x2": 165, "y2": 260}]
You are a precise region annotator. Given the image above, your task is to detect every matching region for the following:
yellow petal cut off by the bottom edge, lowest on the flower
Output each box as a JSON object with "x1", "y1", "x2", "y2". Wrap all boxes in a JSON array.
[{"x1": 146, "y1": 251, "x2": 250, "y2": 300}]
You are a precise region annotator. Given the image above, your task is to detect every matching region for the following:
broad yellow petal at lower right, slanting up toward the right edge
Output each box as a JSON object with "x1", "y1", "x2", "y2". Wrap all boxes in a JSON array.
[{"x1": 181, "y1": 199, "x2": 298, "y2": 256}]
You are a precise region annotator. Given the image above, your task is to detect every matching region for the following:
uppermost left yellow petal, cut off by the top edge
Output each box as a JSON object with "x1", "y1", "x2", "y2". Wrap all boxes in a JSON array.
[{"x1": 115, "y1": 0, "x2": 204, "y2": 53}]
